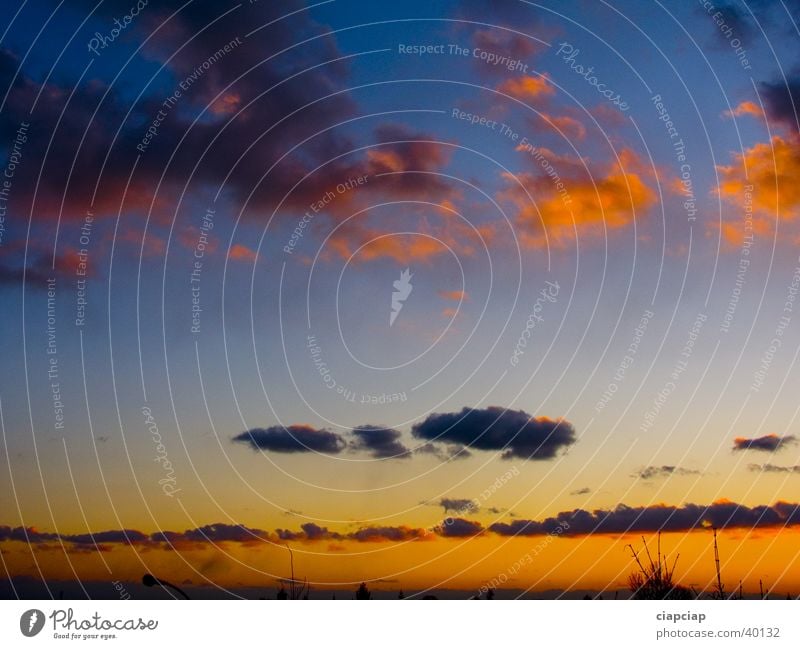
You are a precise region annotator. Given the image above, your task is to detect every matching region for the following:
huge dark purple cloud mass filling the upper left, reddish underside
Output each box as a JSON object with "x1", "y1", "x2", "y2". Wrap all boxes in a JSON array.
[{"x1": 0, "y1": 0, "x2": 482, "y2": 284}]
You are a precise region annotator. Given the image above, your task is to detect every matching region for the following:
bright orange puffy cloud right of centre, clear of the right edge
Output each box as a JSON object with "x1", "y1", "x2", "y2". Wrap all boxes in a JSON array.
[{"x1": 498, "y1": 147, "x2": 656, "y2": 248}]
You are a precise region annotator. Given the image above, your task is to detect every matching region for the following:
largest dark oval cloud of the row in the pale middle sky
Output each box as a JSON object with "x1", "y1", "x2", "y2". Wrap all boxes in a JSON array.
[{"x1": 412, "y1": 406, "x2": 575, "y2": 460}]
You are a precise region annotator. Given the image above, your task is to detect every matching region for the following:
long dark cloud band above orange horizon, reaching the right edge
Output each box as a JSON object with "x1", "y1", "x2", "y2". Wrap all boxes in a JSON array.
[{"x1": 489, "y1": 500, "x2": 800, "y2": 536}]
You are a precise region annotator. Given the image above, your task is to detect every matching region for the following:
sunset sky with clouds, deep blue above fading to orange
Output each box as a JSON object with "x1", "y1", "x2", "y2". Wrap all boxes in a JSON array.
[{"x1": 0, "y1": 0, "x2": 800, "y2": 597}]
